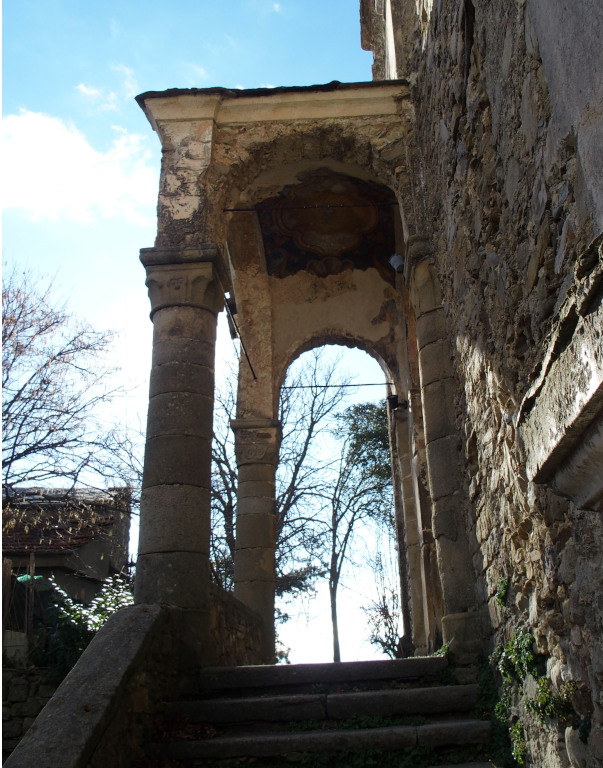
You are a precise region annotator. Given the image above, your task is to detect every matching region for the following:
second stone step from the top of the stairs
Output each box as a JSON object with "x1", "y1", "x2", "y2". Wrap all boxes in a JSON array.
[{"x1": 165, "y1": 685, "x2": 479, "y2": 725}]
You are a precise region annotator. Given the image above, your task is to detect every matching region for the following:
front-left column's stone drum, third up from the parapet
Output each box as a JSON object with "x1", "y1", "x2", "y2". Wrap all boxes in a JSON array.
[{"x1": 142, "y1": 435, "x2": 211, "y2": 488}]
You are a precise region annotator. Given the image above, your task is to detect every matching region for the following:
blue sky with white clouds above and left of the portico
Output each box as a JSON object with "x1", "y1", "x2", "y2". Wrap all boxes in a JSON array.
[{"x1": 2, "y1": 0, "x2": 390, "y2": 660}]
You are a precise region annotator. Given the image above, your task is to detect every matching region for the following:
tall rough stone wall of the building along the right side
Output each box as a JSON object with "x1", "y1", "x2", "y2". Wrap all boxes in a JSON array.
[{"x1": 362, "y1": 0, "x2": 603, "y2": 768}]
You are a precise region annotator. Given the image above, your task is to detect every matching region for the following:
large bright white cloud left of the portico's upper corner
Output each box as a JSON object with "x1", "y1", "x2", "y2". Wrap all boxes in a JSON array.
[{"x1": 2, "y1": 110, "x2": 158, "y2": 226}]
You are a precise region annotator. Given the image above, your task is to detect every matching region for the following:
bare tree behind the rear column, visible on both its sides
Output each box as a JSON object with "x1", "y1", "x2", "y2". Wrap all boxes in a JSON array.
[{"x1": 211, "y1": 350, "x2": 349, "y2": 596}]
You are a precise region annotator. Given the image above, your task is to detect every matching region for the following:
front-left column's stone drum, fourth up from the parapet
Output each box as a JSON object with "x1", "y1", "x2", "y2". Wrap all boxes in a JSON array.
[{"x1": 147, "y1": 392, "x2": 213, "y2": 440}]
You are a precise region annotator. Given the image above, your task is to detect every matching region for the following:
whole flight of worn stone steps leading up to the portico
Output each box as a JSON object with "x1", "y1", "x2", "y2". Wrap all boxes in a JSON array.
[{"x1": 144, "y1": 657, "x2": 490, "y2": 768}]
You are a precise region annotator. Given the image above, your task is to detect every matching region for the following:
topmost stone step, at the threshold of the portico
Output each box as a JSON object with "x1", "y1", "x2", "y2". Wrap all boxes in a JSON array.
[{"x1": 189, "y1": 656, "x2": 448, "y2": 694}]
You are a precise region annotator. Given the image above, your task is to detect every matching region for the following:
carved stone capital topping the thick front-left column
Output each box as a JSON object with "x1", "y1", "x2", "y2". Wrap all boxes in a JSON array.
[{"x1": 140, "y1": 244, "x2": 224, "y2": 318}]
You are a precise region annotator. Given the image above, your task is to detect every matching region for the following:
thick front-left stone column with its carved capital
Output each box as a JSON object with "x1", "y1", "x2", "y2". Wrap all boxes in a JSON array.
[{"x1": 135, "y1": 245, "x2": 223, "y2": 665}]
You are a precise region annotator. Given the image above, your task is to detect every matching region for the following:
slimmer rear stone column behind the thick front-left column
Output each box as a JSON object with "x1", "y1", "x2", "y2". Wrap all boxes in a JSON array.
[{"x1": 231, "y1": 418, "x2": 281, "y2": 664}]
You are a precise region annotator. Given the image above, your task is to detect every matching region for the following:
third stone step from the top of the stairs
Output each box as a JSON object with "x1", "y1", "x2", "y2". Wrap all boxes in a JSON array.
[{"x1": 149, "y1": 719, "x2": 490, "y2": 762}]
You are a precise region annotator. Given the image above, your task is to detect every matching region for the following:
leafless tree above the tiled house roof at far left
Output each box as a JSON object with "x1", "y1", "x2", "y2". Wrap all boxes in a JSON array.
[{"x1": 2, "y1": 269, "x2": 136, "y2": 495}]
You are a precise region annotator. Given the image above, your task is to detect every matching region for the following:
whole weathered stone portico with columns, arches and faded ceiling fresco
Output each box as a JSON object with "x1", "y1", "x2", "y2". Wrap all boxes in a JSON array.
[{"x1": 137, "y1": 80, "x2": 480, "y2": 663}]
